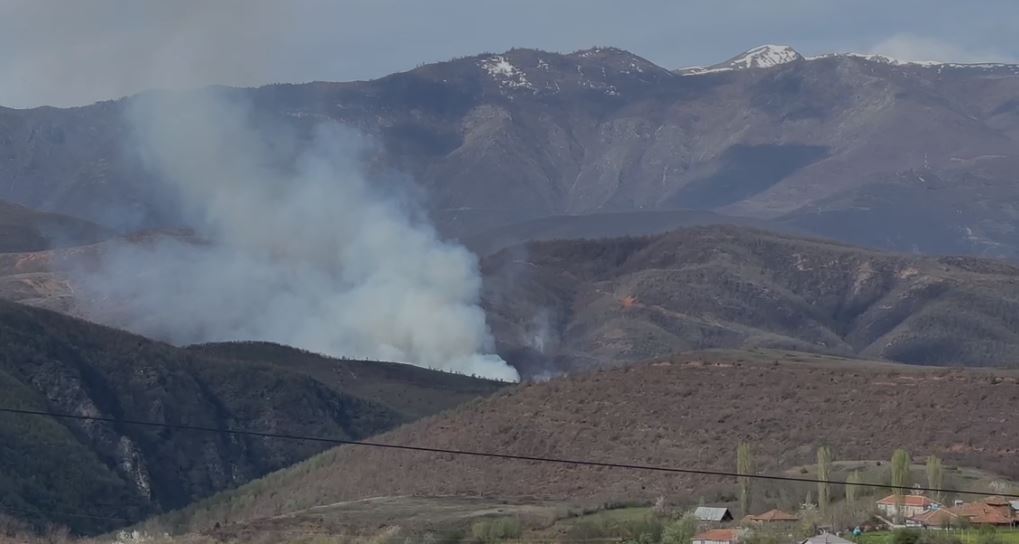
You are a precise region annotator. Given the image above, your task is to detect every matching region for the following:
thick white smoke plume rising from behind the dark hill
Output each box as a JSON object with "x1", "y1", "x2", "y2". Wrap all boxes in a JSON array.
[{"x1": 76, "y1": 91, "x2": 519, "y2": 381}]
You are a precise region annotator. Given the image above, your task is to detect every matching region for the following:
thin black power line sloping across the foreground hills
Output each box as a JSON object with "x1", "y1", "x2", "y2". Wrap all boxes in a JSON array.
[{"x1": 0, "y1": 407, "x2": 1019, "y2": 498}]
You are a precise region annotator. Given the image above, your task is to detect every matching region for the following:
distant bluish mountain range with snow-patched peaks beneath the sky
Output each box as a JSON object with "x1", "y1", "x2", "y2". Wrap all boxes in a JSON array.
[{"x1": 0, "y1": 46, "x2": 1019, "y2": 259}]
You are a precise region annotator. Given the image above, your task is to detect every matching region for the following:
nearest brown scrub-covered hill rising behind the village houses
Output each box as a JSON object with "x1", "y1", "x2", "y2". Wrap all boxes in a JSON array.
[{"x1": 148, "y1": 350, "x2": 1019, "y2": 528}]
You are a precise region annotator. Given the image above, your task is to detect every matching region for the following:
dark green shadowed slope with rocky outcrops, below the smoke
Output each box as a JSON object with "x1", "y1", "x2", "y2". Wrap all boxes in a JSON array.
[{"x1": 0, "y1": 302, "x2": 499, "y2": 531}]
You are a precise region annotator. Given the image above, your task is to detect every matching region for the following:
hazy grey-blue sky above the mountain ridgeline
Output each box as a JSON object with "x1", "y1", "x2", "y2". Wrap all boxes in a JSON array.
[{"x1": 0, "y1": 0, "x2": 1019, "y2": 107}]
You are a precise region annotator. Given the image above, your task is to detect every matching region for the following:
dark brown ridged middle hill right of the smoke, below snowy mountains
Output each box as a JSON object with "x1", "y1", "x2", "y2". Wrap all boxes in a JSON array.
[{"x1": 482, "y1": 226, "x2": 1019, "y2": 376}]
